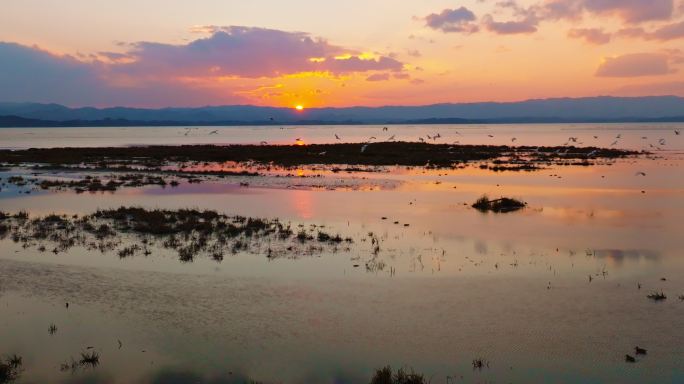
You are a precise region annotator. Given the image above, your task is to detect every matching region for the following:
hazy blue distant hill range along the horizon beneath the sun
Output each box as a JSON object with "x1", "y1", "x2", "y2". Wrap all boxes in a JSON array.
[{"x1": 0, "y1": 96, "x2": 684, "y2": 127}]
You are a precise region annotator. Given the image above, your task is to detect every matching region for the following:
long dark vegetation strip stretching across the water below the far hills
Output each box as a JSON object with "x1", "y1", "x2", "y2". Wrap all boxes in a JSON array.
[{"x1": 0, "y1": 142, "x2": 639, "y2": 167}]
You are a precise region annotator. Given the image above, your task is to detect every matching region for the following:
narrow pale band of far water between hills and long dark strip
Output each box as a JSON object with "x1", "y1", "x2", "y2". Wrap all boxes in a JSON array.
[{"x1": 0, "y1": 123, "x2": 684, "y2": 151}]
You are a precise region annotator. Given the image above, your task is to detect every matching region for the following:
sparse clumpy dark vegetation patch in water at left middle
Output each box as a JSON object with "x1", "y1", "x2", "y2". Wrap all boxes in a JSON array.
[{"x1": 0, "y1": 207, "x2": 353, "y2": 262}]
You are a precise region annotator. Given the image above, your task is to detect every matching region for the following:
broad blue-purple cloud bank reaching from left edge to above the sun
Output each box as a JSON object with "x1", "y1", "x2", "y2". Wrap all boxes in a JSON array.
[{"x1": 0, "y1": 26, "x2": 404, "y2": 105}]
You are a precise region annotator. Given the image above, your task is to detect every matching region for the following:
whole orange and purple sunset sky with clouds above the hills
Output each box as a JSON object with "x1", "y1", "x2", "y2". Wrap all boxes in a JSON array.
[{"x1": 0, "y1": 0, "x2": 684, "y2": 107}]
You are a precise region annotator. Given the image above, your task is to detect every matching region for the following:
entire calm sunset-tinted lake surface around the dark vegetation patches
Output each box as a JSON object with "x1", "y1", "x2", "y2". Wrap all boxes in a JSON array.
[{"x1": 0, "y1": 125, "x2": 684, "y2": 383}]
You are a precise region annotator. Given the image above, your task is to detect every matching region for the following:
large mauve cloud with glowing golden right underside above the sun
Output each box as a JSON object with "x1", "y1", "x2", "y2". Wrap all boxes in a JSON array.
[{"x1": 116, "y1": 27, "x2": 403, "y2": 78}]
